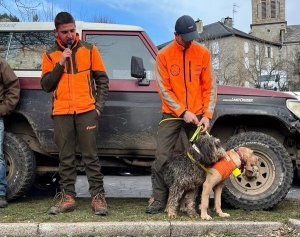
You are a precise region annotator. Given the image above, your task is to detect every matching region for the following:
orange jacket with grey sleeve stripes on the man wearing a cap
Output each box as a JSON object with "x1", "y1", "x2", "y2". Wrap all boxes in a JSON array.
[{"x1": 154, "y1": 39, "x2": 217, "y2": 119}]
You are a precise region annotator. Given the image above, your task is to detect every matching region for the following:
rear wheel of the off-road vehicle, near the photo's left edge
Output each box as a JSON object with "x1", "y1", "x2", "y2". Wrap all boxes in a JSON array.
[{"x1": 3, "y1": 133, "x2": 36, "y2": 200}]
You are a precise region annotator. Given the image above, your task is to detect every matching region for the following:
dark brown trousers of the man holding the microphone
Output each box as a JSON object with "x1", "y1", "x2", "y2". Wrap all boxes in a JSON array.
[{"x1": 53, "y1": 110, "x2": 104, "y2": 197}]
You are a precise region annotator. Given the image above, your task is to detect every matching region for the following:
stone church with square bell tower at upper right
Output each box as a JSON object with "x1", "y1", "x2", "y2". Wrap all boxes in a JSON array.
[{"x1": 250, "y1": 0, "x2": 300, "y2": 90}]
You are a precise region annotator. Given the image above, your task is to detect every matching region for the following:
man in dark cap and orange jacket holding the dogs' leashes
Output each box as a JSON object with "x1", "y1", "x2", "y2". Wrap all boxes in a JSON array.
[{"x1": 146, "y1": 15, "x2": 217, "y2": 214}]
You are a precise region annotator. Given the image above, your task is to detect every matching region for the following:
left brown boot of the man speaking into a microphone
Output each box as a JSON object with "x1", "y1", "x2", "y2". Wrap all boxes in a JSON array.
[{"x1": 50, "y1": 191, "x2": 76, "y2": 215}]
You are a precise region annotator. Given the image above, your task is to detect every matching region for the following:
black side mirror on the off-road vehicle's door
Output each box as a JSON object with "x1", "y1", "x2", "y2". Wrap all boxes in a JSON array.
[{"x1": 131, "y1": 56, "x2": 150, "y2": 86}]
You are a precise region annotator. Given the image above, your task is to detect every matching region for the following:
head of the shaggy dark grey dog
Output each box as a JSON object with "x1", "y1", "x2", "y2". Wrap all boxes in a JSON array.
[{"x1": 188, "y1": 135, "x2": 226, "y2": 166}]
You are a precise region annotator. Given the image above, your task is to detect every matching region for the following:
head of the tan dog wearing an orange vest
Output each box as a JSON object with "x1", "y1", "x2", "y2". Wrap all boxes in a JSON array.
[{"x1": 229, "y1": 147, "x2": 259, "y2": 178}]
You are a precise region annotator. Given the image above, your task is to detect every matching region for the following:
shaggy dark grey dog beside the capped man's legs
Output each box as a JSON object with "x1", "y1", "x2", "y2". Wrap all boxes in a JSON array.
[{"x1": 163, "y1": 135, "x2": 226, "y2": 218}]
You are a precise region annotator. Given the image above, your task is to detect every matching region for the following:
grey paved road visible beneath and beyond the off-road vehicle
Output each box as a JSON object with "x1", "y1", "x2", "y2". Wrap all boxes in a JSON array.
[{"x1": 75, "y1": 175, "x2": 300, "y2": 198}]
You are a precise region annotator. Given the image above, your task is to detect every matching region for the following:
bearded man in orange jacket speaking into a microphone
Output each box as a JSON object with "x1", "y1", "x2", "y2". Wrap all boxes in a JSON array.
[{"x1": 41, "y1": 12, "x2": 108, "y2": 216}]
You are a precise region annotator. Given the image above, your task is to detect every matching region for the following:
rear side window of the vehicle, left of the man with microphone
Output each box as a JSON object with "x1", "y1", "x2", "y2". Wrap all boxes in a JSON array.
[{"x1": 0, "y1": 31, "x2": 55, "y2": 71}]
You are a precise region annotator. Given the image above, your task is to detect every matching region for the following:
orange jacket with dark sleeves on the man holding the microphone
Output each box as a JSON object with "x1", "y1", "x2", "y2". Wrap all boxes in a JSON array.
[{"x1": 41, "y1": 34, "x2": 109, "y2": 115}]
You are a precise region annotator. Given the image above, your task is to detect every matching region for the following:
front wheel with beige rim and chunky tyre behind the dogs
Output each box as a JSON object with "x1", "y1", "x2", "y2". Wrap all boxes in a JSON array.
[{"x1": 222, "y1": 132, "x2": 293, "y2": 210}]
